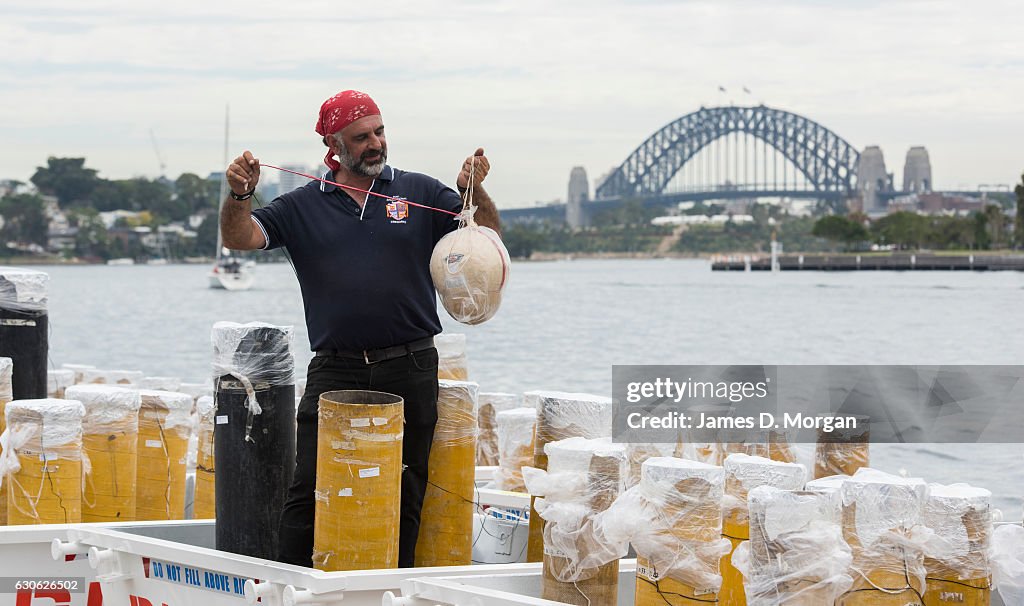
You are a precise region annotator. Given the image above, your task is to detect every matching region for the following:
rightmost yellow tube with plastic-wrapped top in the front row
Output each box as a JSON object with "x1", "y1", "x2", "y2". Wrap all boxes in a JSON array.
[{"x1": 923, "y1": 484, "x2": 992, "y2": 604}]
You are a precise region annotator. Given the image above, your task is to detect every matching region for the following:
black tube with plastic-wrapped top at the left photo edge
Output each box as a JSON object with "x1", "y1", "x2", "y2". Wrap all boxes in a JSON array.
[{"x1": 0, "y1": 267, "x2": 50, "y2": 400}]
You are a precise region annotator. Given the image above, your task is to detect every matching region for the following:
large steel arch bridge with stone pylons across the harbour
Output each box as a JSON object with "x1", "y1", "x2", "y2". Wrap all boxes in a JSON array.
[{"x1": 502, "y1": 105, "x2": 983, "y2": 223}]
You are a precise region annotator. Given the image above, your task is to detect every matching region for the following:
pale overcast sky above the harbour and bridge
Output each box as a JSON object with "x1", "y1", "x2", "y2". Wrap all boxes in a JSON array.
[{"x1": 0, "y1": 0, "x2": 1024, "y2": 208}]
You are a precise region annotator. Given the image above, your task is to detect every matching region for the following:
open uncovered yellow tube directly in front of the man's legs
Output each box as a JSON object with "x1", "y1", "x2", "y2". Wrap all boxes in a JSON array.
[{"x1": 312, "y1": 391, "x2": 404, "y2": 571}]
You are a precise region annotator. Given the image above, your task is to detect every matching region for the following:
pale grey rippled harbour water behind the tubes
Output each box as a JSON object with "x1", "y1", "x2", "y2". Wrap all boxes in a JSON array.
[{"x1": 42, "y1": 260, "x2": 1024, "y2": 520}]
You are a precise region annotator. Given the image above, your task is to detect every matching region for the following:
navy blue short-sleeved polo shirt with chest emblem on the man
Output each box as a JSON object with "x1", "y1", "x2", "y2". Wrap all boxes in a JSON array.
[{"x1": 253, "y1": 166, "x2": 462, "y2": 351}]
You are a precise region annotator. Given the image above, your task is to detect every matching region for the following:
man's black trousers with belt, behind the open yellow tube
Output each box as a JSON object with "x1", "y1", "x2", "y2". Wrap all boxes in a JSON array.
[{"x1": 278, "y1": 347, "x2": 437, "y2": 568}]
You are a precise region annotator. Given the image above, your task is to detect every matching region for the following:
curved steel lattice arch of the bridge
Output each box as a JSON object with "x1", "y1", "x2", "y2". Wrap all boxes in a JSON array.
[{"x1": 594, "y1": 105, "x2": 860, "y2": 199}]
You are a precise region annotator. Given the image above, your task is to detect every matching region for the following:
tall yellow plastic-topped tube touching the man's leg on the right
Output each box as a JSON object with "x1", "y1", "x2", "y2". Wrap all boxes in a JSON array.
[{"x1": 416, "y1": 381, "x2": 479, "y2": 566}]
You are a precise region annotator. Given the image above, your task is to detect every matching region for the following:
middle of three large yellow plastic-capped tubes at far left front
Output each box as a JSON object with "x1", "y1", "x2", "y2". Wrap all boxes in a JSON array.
[{"x1": 67, "y1": 385, "x2": 142, "y2": 522}]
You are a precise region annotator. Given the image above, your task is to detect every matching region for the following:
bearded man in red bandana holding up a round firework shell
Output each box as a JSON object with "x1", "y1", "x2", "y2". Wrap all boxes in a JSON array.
[{"x1": 220, "y1": 90, "x2": 499, "y2": 567}]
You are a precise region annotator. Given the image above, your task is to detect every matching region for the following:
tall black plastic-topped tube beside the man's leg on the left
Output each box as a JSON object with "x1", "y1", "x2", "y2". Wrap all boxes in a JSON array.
[{"x1": 209, "y1": 322, "x2": 295, "y2": 559}]
